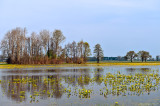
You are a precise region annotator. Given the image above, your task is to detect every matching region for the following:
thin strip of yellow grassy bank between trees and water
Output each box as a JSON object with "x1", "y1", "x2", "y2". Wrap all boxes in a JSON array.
[{"x1": 0, "y1": 61, "x2": 160, "y2": 69}]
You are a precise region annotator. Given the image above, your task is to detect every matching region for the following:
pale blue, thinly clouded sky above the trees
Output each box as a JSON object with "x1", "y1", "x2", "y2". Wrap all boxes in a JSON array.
[{"x1": 0, "y1": 0, "x2": 160, "y2": 57}]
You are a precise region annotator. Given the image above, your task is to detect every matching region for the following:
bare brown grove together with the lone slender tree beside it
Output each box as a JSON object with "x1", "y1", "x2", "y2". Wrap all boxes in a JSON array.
[{"x1": 1, "y1": 27, "x2": 103, "y2": 64}]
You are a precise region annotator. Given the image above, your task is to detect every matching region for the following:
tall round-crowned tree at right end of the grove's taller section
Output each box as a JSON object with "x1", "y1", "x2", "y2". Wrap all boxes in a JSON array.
[{"x1": 53, "y1": 30, "x2": 66, "y2": 58}]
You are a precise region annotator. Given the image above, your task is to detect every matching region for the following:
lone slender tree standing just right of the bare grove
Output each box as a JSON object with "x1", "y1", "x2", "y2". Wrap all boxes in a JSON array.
[{"x1": 94, "y1": 44, "x2": 103, "y2": 63}]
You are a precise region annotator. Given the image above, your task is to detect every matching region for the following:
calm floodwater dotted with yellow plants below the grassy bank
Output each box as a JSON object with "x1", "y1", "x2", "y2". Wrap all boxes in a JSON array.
[{"x1": 0, "y1": 66, "x2": 160, "y2": 106}]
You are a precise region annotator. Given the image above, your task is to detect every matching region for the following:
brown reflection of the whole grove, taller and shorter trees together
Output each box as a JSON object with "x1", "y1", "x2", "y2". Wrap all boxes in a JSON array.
[{"x1": 1, "y1": 69, "x2": 90, "y2": 101}]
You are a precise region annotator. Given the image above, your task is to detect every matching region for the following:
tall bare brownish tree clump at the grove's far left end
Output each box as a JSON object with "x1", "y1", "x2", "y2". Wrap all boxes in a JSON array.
[{"x1": 1, "y1": 27, "x2": 26, "y2": 63}]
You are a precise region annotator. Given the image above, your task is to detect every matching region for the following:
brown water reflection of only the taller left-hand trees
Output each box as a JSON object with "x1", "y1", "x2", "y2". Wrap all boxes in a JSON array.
[{"x1": 1, "y1": 75, "x2": 63, "y2": 101}]
